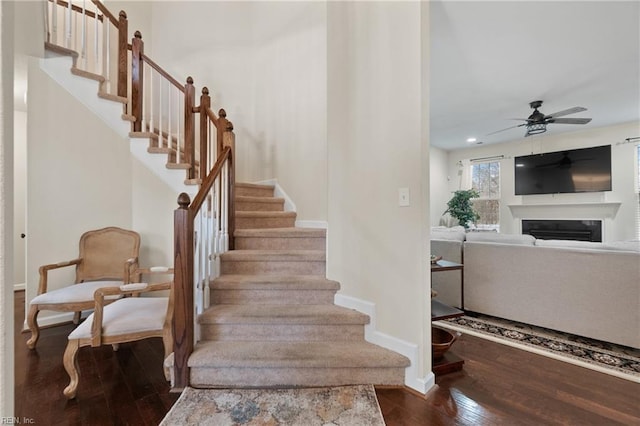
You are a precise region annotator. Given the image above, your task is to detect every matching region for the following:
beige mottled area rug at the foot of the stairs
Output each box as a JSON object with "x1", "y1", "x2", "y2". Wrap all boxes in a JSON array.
[{"x1": 160, "y1": 385, "x2": 385, "y2": 426}]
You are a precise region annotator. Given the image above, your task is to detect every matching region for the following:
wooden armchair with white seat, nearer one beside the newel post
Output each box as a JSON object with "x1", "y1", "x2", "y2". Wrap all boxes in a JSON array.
[{"x1": 63, "y1": 268, "x2": 173, "y2": 399}]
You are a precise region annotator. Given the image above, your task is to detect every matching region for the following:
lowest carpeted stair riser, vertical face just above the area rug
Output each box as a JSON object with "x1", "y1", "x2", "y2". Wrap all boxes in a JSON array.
[{"x1": 191, "y1": 367, "x2": 404, "y2": 389}]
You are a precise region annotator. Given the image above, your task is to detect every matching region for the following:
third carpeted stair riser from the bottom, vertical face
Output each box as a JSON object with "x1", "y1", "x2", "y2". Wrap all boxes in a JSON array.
[{"x1": 211, "y1": 289, "x2": 336, "y2": 305}]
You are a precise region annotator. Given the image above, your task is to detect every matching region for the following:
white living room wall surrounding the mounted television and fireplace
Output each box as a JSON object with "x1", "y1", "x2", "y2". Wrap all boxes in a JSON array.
[{"x1": 438, "y1": 122, "x2": 640, "y2": 241}]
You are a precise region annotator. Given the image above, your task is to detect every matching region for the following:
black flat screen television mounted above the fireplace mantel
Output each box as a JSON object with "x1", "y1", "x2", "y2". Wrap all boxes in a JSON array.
[{"x1": 514, "y1": 145, "x2": 611, "y2": 195}]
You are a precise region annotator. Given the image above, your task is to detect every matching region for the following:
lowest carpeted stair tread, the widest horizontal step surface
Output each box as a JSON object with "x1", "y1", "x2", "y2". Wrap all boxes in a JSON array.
[{"x1": 189, "y1": 341, "x2": 410, "y2": 369}]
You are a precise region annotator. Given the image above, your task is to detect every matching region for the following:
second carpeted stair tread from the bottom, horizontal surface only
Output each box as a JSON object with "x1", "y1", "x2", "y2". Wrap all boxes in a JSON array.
[{"x1": 198, "y1": 304, "x2": 369, "y2": 326}]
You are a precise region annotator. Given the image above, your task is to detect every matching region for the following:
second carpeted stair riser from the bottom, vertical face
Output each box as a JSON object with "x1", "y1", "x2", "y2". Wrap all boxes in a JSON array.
[{"x1": 200, "y1": 323, "x2": 364, "y2": 342}]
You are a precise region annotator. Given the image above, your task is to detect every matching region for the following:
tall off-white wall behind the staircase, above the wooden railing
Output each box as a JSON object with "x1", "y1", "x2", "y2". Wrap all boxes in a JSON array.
[{"x1": 143, "y1": 2, "x2": 327, "y2": 220}]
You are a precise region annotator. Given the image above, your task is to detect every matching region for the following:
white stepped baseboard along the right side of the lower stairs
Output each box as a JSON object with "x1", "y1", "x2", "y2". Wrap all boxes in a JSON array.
[{"x1": 335, "y1": 294, "x2": 436, "y2": 394}]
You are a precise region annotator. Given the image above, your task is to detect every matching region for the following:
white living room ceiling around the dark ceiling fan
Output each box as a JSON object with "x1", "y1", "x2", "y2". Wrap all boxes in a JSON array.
[{"x1": 430, "y1": 0, "x2": 640, "y2": 150}]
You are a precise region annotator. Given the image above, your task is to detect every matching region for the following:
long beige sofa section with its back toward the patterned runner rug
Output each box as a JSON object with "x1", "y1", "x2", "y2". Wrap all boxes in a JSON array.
[{"x1": 462, "y1": 233, "x2": 640, "y2": 348}]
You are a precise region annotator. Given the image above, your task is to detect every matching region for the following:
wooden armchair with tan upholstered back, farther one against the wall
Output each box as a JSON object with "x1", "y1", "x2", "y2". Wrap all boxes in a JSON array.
[{"x1": 27, "y1": 227, "x2": 140, "y2": 349}]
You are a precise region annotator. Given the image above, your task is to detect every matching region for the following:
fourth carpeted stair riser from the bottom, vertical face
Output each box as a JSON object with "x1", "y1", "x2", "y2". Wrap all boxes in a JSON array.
[{"x1": 221, "y1": 261, "x2": 326, "y2": 276}]
